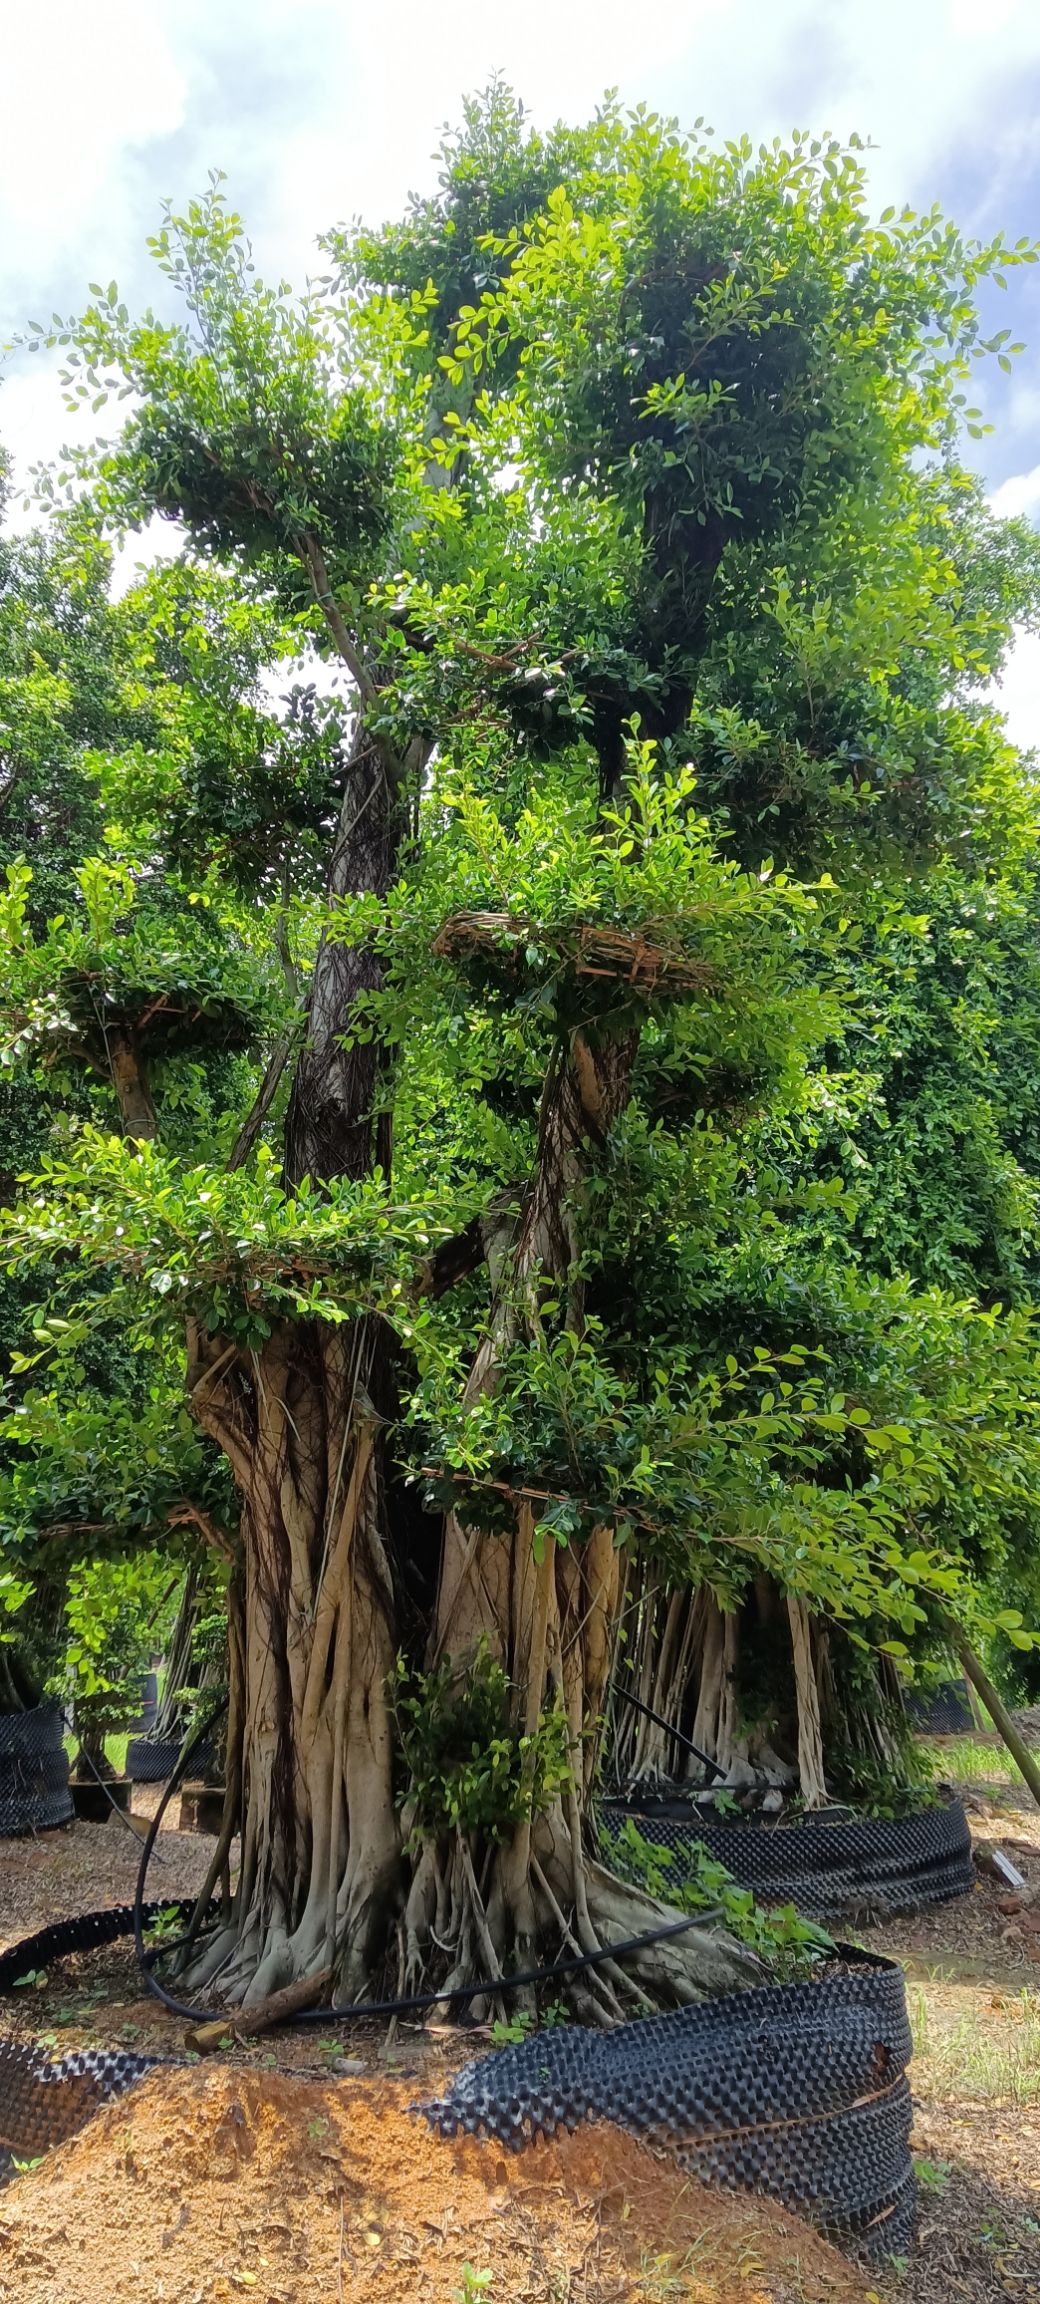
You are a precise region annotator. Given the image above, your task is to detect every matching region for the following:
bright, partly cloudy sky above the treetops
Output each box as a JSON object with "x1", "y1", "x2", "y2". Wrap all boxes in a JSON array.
[{"x1": 0, "y1": 0, "x2": 1040, "y2": 746}]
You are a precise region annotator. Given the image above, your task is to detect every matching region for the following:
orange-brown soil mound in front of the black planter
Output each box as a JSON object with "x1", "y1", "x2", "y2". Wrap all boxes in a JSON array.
[{"x1": 0, "y1": 2067, "x2": 867, "y2": 2304}]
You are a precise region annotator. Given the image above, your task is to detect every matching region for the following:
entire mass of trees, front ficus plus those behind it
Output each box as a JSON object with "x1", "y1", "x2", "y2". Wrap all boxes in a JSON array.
[{"x1": 0, "y1": 90, "x2": 1040, "y2": 2016}]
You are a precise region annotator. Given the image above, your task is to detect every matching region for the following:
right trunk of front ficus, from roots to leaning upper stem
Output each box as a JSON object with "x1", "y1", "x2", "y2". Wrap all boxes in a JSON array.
[{"x1": 406, "y1": 1034, "x2": 752, "y2": 2021}]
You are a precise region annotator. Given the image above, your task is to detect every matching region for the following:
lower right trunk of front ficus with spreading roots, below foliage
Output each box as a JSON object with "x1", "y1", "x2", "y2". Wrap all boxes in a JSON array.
[{"x1": 406, "y1": 1505, "x2": 756, "y2": 2023}]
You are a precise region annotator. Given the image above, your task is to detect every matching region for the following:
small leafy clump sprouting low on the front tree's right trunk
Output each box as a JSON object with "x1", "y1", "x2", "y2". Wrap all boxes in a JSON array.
[{"x1": 392, "y1": 1643, "x2": 570, "y2": 1841}]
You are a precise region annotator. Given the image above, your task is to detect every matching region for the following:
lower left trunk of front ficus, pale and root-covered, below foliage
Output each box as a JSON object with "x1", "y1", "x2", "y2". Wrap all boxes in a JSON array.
[{"x1": 185, "y1": 1322, "x2": 401, "y2": 2002}]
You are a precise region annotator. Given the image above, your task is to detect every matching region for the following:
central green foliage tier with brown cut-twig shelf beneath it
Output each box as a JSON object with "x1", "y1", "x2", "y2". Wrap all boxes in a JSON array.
[{"x1": 334, "y1": 742, "x2": 823, "y2": 1048}]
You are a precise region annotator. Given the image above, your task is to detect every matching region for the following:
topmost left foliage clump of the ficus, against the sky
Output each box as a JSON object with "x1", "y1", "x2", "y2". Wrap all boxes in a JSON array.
[{"x1": 31, "y1": 175, "x2": 392, "y2": 604}]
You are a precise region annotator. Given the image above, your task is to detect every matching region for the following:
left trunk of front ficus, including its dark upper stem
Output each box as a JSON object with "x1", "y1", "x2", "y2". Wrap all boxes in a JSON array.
[{"x1": 189, "y1": 721, "x2": 412, "y2": 2004}]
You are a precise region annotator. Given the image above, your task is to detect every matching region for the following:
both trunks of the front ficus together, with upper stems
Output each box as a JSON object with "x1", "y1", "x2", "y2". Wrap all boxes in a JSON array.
[{"x1": 187, "y1": 730, "x2": 759, "y2": 2021}]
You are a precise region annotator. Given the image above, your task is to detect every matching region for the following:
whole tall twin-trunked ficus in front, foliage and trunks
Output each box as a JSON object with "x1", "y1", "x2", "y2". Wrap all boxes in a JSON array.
[{"x1": 9, "y1": 103, "x2": 1038, "y2": 2018}]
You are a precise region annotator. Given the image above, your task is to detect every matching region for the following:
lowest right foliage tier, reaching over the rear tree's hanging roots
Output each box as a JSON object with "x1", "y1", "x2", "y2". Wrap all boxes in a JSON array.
[{"x1": 417, "y1": 1295, "x2": 1040, "y2": 1654}]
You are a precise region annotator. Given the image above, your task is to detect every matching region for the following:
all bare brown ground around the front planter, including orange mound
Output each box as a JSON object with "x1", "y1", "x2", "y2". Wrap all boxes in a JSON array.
[{"x1": 0, "y1": 1793, "x2": 1040, "y2": 2304}]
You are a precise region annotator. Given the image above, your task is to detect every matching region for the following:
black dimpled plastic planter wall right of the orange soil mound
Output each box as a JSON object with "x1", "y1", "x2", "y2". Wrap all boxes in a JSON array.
[{"x1": 424, "y1": 1951, "x2": 915, "y2": 2256}]
